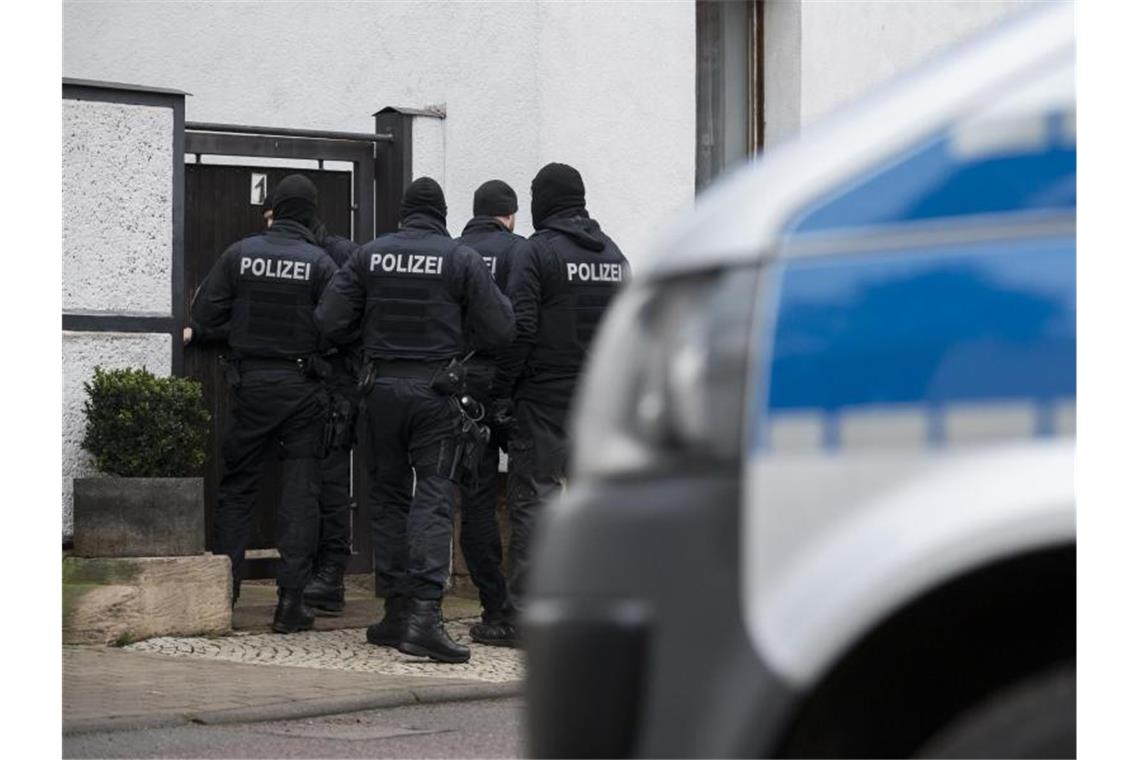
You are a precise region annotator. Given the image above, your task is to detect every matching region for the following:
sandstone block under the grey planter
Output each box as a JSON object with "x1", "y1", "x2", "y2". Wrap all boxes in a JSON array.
[{"x1": 63, "y1": 554, "x2": 230, "y2": 644}]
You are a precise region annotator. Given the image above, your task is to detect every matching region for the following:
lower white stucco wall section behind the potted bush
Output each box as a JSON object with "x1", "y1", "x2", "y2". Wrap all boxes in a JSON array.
[{"x1": 63, "y1": 332, "x2": 173, "y2": 541}]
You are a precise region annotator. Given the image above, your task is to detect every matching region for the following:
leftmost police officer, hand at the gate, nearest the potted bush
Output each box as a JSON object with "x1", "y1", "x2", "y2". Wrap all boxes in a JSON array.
[{"x1": 190, "y1": 174, "x2": 336, "y2": 634}]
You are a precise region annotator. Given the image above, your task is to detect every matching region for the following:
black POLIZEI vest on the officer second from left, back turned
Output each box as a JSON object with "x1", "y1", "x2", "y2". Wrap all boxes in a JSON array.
[{"x1": 360, "y1": 229, "x2": 464, "y2": 360}]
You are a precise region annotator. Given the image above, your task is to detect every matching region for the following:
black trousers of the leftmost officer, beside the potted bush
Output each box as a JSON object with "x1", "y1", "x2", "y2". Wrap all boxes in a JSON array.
[{"x1": 214, "y1": 369, "x2": 327, "y2": 588}]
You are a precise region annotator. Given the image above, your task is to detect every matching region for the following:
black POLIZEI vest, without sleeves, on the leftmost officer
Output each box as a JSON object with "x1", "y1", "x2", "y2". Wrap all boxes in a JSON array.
[{"x1": 229, "y1": 232, "x2": 332, "y2": 359}]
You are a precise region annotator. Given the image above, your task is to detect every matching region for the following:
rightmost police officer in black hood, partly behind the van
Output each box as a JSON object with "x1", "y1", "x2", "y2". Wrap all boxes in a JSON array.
[{"x1": 495, "y1": 163, "x2": 629, "y2": 638}]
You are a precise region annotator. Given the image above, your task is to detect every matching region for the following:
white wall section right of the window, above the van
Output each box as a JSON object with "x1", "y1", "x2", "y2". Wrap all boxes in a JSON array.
[{"x1": 764, "y1": 0, "x2": 1033, "y2": 146}]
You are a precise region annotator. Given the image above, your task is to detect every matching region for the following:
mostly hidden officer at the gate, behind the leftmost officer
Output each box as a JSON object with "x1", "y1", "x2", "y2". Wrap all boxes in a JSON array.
[{"x1": 304, "y1": 220, "x2": 360, "y2": 615}]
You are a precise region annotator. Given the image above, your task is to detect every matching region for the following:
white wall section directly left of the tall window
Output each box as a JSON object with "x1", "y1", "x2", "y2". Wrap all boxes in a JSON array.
[{"x1": 533, "y1": 2, "x2": 697, "y2": 267}]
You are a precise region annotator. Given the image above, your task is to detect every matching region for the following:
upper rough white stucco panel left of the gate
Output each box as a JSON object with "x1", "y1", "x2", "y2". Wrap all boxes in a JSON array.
[{"x1": 63, "y1": 100, "x2": 174, "y2": 316}]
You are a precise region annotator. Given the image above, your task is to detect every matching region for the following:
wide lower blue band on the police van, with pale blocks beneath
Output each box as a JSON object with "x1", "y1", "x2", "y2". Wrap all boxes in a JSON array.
[{"x1": 754, "y1": 236, "x2": 1076, "y2": 450}]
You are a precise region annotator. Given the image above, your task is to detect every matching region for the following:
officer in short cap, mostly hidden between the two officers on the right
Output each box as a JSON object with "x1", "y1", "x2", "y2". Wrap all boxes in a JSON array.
[{"x1": 459, "y1": 179, "x2": 526, "y2": 646}]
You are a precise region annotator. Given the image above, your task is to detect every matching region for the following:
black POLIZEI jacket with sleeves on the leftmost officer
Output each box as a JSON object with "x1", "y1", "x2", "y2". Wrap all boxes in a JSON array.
[{"x1": 190, "y1": 220, "x2": 336, "y2": 359}]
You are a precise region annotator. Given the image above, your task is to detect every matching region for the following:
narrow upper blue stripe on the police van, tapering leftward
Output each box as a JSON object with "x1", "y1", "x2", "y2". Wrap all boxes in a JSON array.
[{"x1": 788, "y1": 106, "x2": 1076, "y2": 236}]
